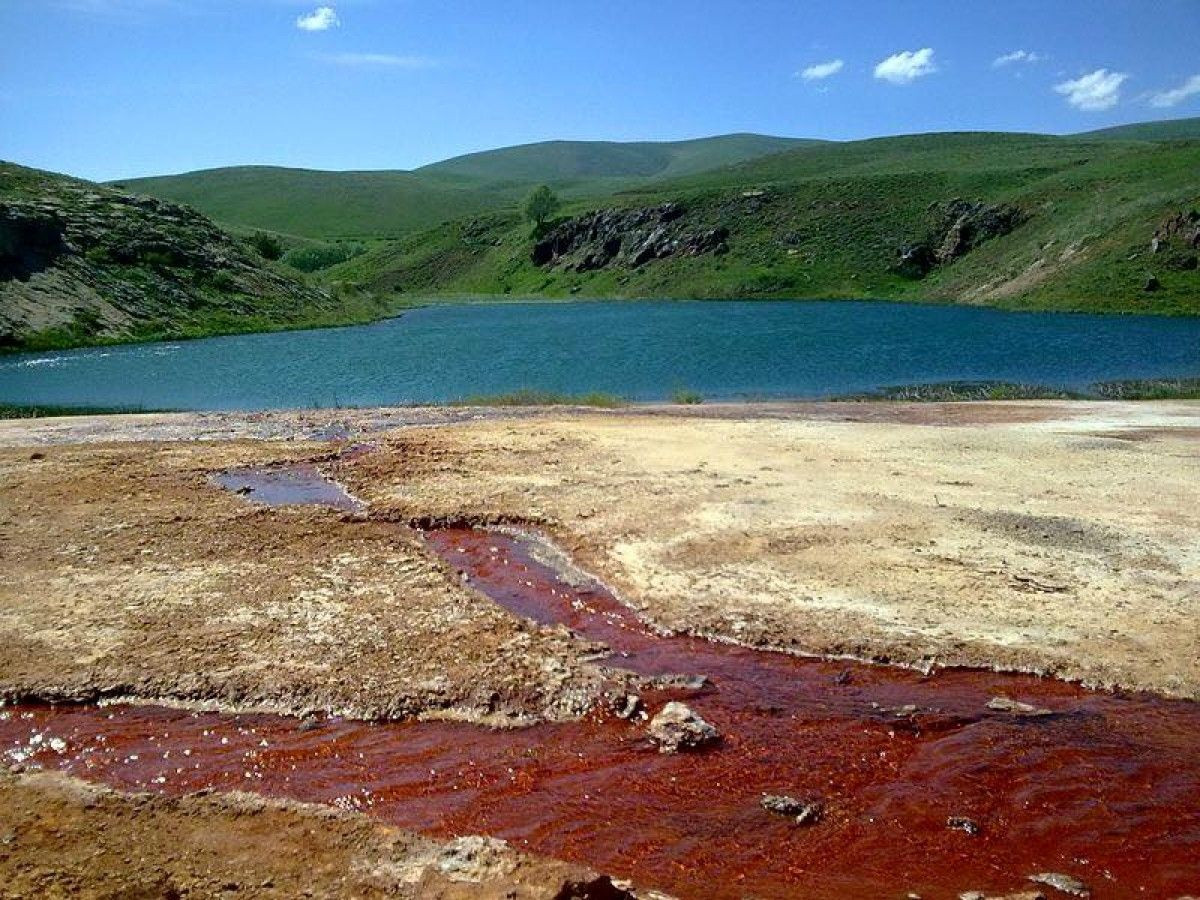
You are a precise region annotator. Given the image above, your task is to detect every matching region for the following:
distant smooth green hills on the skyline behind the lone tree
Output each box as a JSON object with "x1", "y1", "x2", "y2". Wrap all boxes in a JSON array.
[{"x1": 116, "y1": 134, "x2": 803, "y2": 240}]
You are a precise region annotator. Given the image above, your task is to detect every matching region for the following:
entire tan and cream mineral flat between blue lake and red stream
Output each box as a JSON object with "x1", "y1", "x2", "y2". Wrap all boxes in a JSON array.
[{"x1": 0, "y1": 402, "x2": 1200, "y2": 714}]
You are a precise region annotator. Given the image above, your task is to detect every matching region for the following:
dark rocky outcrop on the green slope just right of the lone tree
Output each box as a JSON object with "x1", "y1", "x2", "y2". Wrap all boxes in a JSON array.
[{"x1": 532, "y1": 203, "x2": 730, "y2": 272}]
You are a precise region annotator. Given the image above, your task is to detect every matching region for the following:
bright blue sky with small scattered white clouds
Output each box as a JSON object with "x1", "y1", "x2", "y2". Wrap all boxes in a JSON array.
[{"x1": 0, "y1": 0, "x2": 1200, "y2": 179}]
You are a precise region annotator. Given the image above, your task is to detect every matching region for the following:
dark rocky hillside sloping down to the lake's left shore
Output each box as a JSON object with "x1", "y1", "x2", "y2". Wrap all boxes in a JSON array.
[{"x1": 0, "y1": 163, "x2": 383, "y2": 350}]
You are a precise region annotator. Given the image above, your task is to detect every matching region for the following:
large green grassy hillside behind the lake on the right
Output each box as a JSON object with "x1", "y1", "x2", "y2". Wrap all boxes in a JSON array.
[{"x1": 330, "y1": 133, "x2": 1200, "y2": 313}]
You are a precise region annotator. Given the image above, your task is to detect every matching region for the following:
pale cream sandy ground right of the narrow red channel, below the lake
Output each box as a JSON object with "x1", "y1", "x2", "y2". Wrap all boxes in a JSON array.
[{"x1": 331, "y1": 403, "x2": 1200, "y2": 697}]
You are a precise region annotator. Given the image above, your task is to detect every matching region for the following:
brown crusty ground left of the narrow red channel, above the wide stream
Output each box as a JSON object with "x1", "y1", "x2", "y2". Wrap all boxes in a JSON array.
[{"x1": 0, "y1": 442, "x2": 601, "y2": 722}]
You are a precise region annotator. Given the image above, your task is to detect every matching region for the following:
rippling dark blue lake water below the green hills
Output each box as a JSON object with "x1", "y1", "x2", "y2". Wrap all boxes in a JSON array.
[{"x1": 0, "y1": 301, "x2": 1200, "y2": 409}]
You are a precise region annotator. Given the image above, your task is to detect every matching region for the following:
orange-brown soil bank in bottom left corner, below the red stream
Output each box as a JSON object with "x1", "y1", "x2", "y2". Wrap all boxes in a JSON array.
[{"x1": 0, "y1": 773, "x2": 634, "y2": 900}]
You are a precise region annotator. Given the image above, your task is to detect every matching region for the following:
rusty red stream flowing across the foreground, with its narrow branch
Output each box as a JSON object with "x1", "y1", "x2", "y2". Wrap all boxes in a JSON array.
[{"x1": 0, "y1": 475, "x2": 1200, "y2": 898}]
